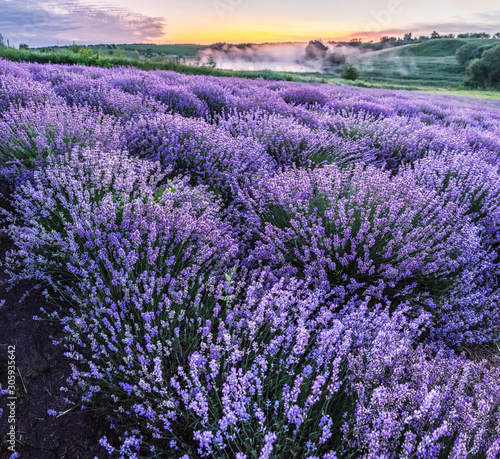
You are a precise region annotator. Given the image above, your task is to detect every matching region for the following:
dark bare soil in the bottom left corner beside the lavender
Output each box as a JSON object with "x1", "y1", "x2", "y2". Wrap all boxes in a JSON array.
[{"x1": 0, "y1": 196, "x2": 109, "y2": 459}]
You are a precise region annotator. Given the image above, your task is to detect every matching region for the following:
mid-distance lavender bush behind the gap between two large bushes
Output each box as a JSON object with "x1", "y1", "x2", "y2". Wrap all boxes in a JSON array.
[{"x1": 121, "y1": 115, "x2": 273, "y2": 201}]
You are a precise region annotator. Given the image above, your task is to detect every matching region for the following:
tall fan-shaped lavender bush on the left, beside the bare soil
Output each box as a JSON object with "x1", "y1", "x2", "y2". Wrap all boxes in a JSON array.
[{"x1": 9, "y1": 150, "x2": 235, "y2": 452}]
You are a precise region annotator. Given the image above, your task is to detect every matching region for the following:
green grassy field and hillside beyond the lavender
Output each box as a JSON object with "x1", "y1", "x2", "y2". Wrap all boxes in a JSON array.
[{"x1": 0, "y1": 39, "x2": 500, "y2": 99}]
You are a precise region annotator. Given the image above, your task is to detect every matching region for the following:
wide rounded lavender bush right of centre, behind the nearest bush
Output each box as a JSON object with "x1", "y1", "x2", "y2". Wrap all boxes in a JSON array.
[{"x1": 248, "y1": 166, "x2": 473, "y2": 301}]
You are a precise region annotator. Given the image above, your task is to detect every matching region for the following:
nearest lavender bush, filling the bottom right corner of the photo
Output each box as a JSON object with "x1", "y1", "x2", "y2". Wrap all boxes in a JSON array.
[{"x1": 168, "y1": 282, "x2": 500, "y2": 458}]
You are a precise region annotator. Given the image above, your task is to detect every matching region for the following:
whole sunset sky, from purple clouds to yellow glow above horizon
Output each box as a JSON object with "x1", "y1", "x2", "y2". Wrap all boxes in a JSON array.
[{"x1": 0, "y1": 0, "x2": 500, "y2": 47}]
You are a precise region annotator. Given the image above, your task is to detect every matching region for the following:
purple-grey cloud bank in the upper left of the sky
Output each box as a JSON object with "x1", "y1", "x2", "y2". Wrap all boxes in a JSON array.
[{"x1": 0, "y1": 0, "x2": 165, "y2": 46}]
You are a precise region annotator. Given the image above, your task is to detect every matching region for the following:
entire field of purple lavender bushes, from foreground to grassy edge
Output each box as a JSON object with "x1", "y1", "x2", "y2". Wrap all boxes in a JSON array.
[{"x1": 0, "y1": 61, "x2": 500, "y2": 459}]
